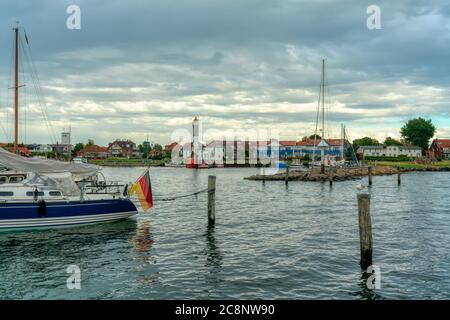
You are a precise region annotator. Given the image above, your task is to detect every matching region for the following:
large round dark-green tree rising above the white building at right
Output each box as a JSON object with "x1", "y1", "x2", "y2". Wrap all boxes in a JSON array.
[{"x1": 400, "y1": 117, "x2": 436, "y2": 152}]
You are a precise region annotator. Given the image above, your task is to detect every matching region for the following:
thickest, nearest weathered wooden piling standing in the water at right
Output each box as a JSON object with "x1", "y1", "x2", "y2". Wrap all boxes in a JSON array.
[{"x1": 358, "y1": 193, "x2": 372, "y2": 270}]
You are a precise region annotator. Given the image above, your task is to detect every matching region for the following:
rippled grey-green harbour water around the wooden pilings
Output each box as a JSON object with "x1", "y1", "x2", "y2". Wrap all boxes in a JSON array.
[{"x1": 0, "y1": 168, "x2": 450, "y2": 299}]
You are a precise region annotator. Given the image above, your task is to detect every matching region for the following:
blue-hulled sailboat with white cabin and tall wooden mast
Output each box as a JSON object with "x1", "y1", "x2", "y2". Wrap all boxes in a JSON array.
[{"x1": 0, "y1": 25, "x2": 138, "y2": 231}]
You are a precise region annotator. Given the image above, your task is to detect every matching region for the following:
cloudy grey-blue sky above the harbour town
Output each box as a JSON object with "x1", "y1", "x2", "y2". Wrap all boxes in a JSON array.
[{"x1": 0, "y1": 0, "x2": 450, "y2": 145}]
